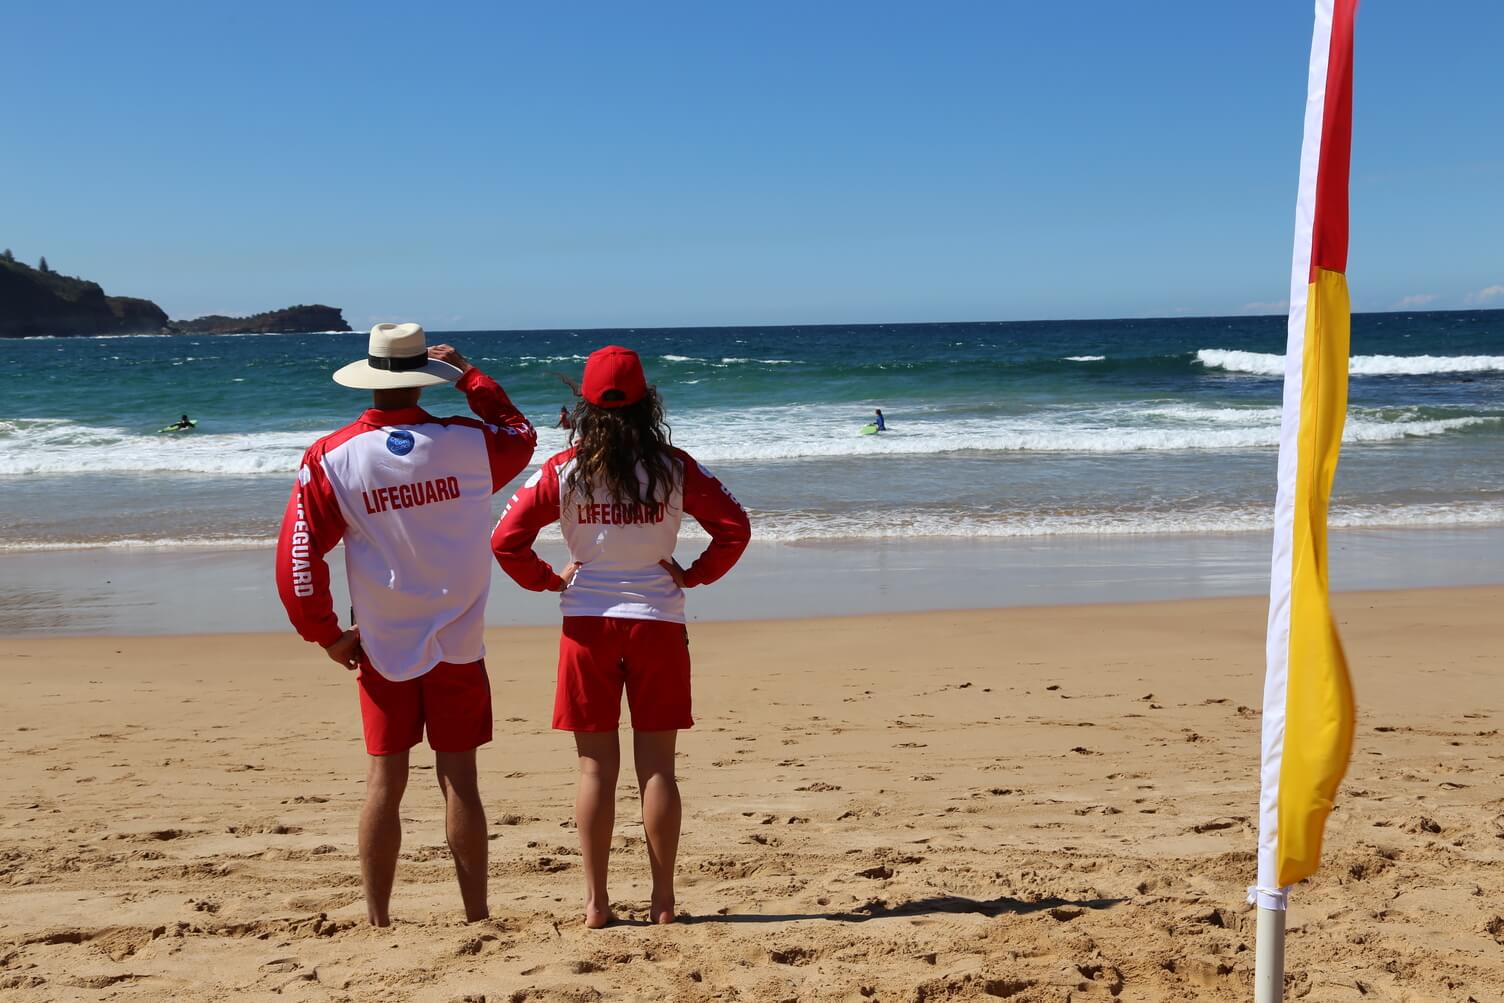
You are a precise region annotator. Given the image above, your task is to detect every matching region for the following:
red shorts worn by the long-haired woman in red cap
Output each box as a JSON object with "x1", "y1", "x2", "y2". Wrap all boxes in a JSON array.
[{"x1": 553, "y1": 617, "x2": 695, "y2": 731}]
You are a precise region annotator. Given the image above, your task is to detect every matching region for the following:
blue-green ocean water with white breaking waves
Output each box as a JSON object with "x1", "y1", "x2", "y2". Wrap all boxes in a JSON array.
[{"x1": 0, "y1": 311, "x2": 1504, "y2": 550}]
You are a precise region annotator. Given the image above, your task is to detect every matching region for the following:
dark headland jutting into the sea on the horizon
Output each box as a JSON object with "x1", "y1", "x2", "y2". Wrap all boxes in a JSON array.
[{"x1": 0, "y1": 251, "x2": 350, "y2": 338}]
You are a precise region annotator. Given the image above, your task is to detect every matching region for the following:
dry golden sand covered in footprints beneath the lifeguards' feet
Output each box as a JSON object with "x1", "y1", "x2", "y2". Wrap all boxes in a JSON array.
[{"x1": 0, "y1": 588, "x2": 1504, "y2": 1003}]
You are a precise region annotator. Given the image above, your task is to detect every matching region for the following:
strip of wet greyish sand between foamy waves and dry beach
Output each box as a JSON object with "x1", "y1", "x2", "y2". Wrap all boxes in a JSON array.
[{"x1": 0, "y1": 526, "x2": 1504, "y2": 638}]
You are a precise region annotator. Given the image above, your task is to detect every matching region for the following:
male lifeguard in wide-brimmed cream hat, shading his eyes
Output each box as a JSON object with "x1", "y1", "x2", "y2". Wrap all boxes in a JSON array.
[{"x1": 277, "y1": 323, "x2": 537, "y2": 926}]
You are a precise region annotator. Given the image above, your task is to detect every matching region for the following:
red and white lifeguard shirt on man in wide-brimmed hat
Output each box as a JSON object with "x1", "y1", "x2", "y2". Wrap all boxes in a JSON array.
[{"x1": 277, "y1": 368, "x2": 537, "y2": 681}]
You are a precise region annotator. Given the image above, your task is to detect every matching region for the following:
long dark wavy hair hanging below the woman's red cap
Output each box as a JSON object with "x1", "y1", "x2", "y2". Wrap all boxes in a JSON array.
[{"x1": 564, "y1": 386, "x2": 674, "y2": 505}]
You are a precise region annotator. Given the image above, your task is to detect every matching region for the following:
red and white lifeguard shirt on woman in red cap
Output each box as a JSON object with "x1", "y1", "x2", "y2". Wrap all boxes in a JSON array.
[{"x1": 490, "y1": 450, "x2": 752, "y2": 624}]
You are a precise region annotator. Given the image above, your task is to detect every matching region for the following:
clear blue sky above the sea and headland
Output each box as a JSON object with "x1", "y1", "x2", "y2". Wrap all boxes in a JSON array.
[{"x1": 0, "y1": 0, "x2": 1504, "y2": 329}]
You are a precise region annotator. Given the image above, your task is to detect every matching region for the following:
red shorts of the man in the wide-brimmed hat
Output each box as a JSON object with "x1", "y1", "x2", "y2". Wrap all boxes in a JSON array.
[{"x1": 356, "y1": 659, "x2": 490, "y2": 756}]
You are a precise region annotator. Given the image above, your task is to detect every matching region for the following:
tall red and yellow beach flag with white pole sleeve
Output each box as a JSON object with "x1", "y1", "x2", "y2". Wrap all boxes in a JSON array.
[{"x1": 1257, "y1": 0, "x2": 1358, "y2": 910}]
